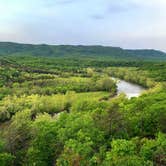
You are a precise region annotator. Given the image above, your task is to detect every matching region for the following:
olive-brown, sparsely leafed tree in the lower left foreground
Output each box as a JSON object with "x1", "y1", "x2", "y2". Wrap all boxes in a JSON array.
[{"x1": 5, "y1": 110, "x2": 32, "y2": 165}]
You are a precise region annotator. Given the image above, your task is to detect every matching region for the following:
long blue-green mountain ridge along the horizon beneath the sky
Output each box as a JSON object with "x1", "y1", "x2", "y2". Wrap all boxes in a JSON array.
[{"x1": 0, "y1": 42, "x2": 166, "y2": 60}]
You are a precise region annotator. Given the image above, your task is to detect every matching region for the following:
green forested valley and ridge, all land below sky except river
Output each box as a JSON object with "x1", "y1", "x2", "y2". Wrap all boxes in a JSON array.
[{"x1": 0, "y1": 43, "x2": 166, "y2": 166}]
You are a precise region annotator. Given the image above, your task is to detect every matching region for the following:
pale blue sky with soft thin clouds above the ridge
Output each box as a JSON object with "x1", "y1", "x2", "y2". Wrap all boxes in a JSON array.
[{"x1": 0, "y1": 0, "x2": 166, "y2": 51}]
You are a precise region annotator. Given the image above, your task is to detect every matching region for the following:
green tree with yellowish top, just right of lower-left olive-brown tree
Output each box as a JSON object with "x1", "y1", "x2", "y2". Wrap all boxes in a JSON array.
[{"x1": 26, "y1": 113, "x2": 58, "y2": 166}]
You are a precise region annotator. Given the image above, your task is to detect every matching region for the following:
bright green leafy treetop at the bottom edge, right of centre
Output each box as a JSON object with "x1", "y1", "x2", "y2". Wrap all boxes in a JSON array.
[{"x1": 103, "y1": 139, "x2": 153, "y2": 166}]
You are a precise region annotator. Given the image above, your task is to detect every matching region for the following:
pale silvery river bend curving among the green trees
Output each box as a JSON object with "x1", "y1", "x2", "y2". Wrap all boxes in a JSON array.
[{"x1": 113, "y1": 78, "x2": 145, "y2": 98}]
